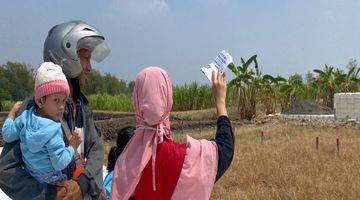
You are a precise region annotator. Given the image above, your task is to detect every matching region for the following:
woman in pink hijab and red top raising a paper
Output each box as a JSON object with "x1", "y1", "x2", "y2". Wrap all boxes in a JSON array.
[{"x1": 111, "y1": 67, "x2": 234, "y2": 200}]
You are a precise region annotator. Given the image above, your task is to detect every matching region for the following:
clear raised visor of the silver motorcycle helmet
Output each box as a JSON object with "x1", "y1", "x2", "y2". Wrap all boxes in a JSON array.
[{"x1": 77, "y1": 36, "x2": 110, "y2": 63}]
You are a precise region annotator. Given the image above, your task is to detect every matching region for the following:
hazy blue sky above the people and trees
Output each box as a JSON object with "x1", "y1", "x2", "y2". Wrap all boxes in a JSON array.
[{"x1": 0, "y1": 0, "x2": 360, "y2": 84}]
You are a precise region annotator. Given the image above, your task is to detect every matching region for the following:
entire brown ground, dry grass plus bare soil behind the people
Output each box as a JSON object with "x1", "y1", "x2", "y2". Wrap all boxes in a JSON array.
[{"x1": 0, "y1": 109, "x2": 360, "y2": 199}]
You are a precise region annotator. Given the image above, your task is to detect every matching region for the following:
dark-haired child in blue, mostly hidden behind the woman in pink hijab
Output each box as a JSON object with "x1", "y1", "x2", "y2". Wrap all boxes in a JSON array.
[{"x1": 104, "y1": 126, "x2": 135, "y2": 199}]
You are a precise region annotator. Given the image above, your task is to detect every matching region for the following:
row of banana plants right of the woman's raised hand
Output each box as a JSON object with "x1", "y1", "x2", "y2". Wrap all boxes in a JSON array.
[{"x1": 229, "y1": 55, "x2": 360, "y2": 119}]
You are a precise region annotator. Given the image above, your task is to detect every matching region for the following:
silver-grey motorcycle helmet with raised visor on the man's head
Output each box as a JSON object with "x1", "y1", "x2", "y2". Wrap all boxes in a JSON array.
[{"x1": 44, "y1": 21, "x2": 110, "y2": 78}]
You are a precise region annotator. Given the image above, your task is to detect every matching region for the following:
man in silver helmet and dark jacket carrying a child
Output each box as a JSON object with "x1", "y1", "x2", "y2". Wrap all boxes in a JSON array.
[{"x1": 0, "y1": 21, "x2": 110, "y2": 199}]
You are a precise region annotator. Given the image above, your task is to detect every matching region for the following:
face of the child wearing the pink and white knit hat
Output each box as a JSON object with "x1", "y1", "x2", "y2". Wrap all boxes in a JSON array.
[{"x1": 37, "y1": 93, "x2": 67, "y2": 121}]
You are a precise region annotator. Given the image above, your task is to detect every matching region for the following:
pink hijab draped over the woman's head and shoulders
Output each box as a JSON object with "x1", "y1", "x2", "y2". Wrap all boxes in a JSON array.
[{"x1": 111, "y1": 67, "x2": 218, "y2": 200}]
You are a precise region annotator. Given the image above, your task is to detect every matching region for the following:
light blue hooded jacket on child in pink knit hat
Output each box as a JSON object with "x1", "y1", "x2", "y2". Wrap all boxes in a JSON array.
[{"x1": 2, "y1": 106, "x2": 74, "y2": 183}]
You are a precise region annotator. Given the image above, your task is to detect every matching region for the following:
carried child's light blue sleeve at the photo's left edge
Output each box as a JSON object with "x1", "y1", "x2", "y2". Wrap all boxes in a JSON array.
[{"x1": 2, "y1": 118, "x2": 22, "y2": 143}]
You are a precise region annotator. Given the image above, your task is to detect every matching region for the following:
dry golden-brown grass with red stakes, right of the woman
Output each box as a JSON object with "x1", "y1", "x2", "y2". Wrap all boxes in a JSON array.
[{"x1": 205, "y1": 124, "x2": 360, "y2": 199}]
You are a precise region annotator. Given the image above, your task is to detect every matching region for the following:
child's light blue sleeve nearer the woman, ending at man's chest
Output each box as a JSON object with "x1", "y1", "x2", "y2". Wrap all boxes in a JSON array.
[{"x1": 46, "y1": 128, "x2": 75, "y2": 171}]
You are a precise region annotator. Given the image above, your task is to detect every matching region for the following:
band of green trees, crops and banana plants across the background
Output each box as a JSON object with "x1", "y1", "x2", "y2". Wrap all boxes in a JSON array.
[{"x1": 0, "y1": 58, "x2": 360, "y2": 114}]
